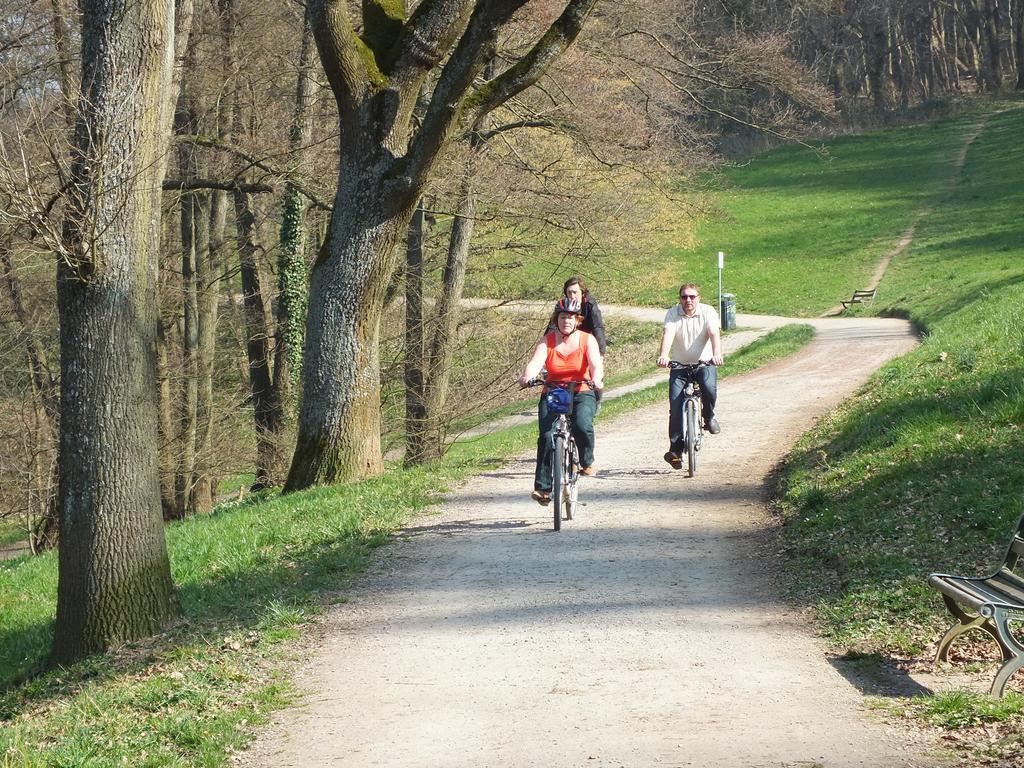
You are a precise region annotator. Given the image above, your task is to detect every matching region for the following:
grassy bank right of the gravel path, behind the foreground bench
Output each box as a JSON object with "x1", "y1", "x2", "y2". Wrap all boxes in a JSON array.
[{"x1": 780, "y1": 102, "x2": 1024, "y2": 764}]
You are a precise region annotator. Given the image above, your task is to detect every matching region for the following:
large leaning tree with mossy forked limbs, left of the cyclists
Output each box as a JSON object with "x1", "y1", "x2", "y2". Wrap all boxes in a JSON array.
[{"x1": 286, "y1": 0, "x2": 596, "y2": 490}]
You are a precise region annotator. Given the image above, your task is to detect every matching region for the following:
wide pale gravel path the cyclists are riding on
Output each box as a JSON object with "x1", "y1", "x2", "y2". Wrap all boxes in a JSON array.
[{"x1": 239, "y1": 318, "x2": 937, "y2": 768}]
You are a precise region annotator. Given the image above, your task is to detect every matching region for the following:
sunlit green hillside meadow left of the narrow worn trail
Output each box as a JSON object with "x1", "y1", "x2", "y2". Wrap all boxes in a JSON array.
[{"x1": 467, "y1": 105, "x2": 978, "y2": 316}]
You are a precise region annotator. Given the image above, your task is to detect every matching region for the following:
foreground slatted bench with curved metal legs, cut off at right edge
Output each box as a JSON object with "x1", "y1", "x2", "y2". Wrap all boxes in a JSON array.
[{"x1": 928, "y1": 515, "x2": 1024, "y2": 696}]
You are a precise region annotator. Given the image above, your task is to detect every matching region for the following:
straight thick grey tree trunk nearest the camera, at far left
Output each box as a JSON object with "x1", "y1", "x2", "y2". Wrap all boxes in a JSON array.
[{"x1": 51, "y1": 0, "x2": 177, "y2": 664}]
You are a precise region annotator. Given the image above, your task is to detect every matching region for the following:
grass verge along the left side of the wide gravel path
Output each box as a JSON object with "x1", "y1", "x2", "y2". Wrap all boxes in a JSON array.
[{"x1": 0, "y1": 326, "x2": 813, "y2": 768}]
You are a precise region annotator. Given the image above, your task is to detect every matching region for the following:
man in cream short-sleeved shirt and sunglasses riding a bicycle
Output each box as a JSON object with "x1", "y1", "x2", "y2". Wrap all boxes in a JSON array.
[{"x1": 657, "y1": 283, "x2": 725, "y2": 469}]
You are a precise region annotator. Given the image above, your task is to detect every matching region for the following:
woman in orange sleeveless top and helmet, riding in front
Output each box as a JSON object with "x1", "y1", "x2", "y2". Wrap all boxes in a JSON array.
[{"x1": 519, "y1": 298, "x2": 604, "y2": 505}]
